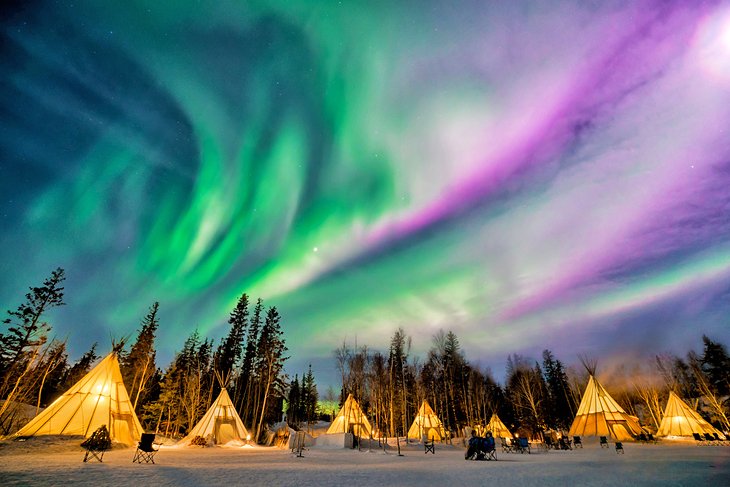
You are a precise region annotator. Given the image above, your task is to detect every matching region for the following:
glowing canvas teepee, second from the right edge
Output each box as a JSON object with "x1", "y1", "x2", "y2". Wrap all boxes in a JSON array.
[{"x1": 569, "y1": 374, "x2": 641, "y2": 440}]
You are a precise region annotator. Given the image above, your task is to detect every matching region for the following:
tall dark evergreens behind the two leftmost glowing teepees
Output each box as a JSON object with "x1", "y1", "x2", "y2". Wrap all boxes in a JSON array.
[{"x1": 0, "y1": 268, "x2": 292, "y2": 439}]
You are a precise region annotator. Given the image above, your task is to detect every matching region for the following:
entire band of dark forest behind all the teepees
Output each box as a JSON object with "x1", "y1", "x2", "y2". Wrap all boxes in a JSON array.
[{"x1": 0, "y1": 268, "x2": 730, "y2": 439}]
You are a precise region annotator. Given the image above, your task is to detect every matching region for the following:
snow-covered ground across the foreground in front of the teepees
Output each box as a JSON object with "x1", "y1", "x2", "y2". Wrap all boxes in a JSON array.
[{"x1": 0, "y1": 438, "x2": 730, "y2": 487}]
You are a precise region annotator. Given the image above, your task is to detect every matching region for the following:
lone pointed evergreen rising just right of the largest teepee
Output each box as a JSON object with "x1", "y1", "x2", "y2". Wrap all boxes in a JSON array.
[{"x1": 121, "y1": 302, "x2": 160, "y2": 413}]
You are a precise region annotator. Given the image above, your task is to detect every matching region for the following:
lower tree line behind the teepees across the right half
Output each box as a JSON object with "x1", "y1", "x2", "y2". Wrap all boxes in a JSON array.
[{"x1": 334, "y1": 328, "x2": 730, "y2": 437}]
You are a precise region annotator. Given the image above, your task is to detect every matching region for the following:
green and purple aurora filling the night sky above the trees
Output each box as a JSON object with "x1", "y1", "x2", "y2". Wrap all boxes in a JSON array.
[{"x1": 0, "y1": 0, "x2": 730, "y2": 380}]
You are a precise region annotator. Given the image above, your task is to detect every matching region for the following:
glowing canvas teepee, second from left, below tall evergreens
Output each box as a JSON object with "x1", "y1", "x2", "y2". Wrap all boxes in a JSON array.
[{"x1": 178, "y1": 387, "x2": 250, "y2": 445}]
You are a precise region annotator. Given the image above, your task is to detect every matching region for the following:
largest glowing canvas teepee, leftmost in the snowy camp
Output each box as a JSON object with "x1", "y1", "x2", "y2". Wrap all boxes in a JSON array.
[{"x1": 8, "y1": 351, "x2": 144, "y2": 445}]
